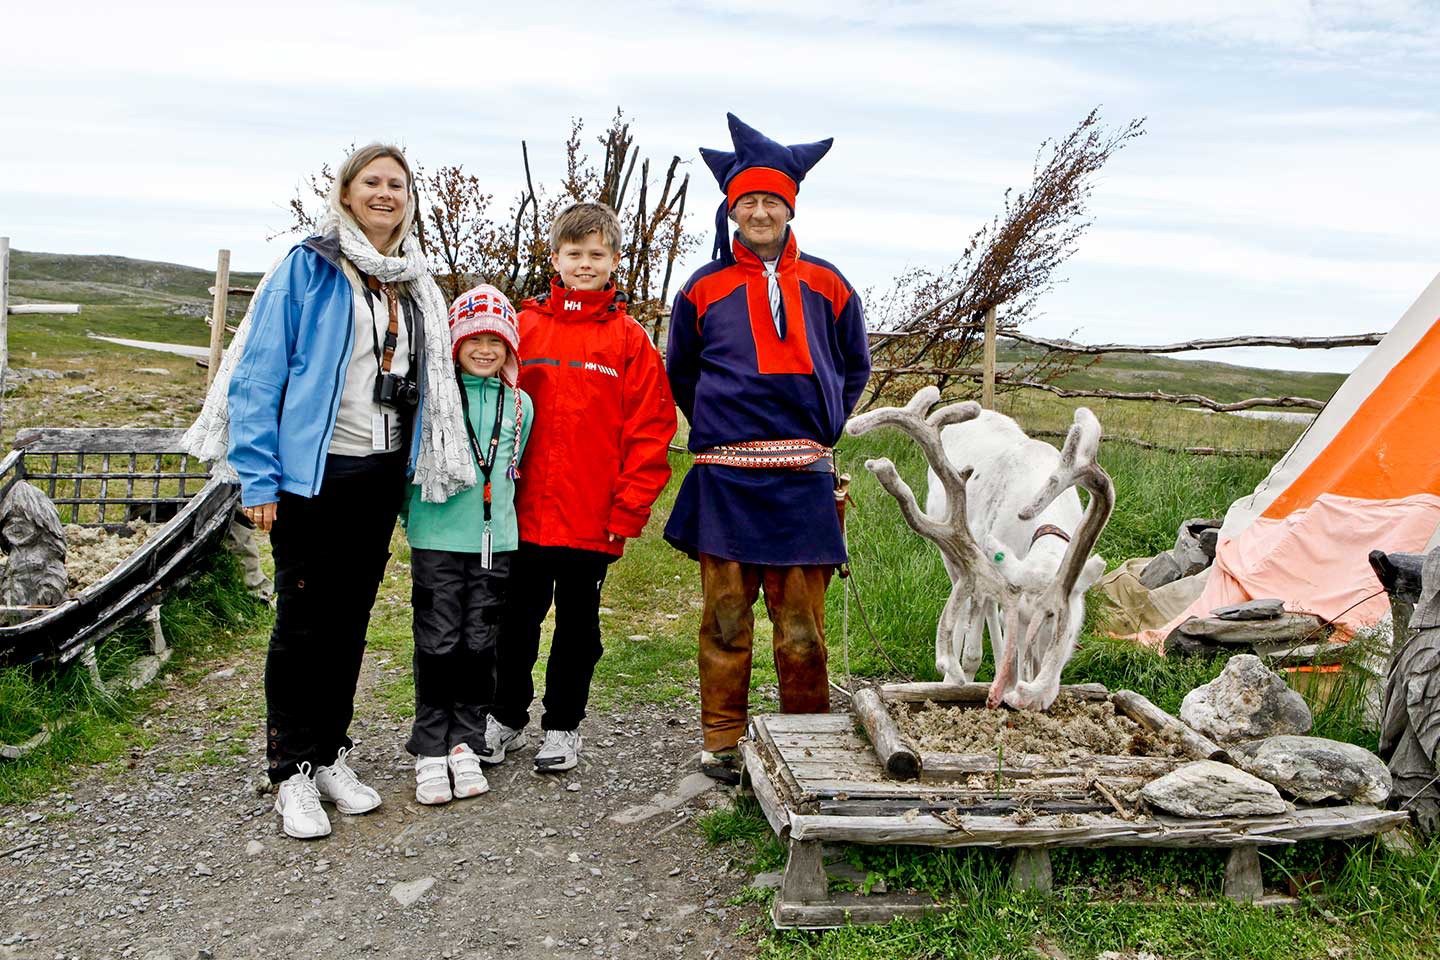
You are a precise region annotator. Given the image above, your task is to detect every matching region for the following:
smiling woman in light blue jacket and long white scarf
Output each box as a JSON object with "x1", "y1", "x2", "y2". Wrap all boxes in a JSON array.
[{"x1": 187, "y1": 144, "x2": 475, "y2": 839}]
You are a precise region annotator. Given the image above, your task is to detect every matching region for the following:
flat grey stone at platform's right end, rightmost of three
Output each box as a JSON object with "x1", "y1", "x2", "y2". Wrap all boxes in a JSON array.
[{"x1": 1230, "y1": 735, "x2": 1390, "y2": 806}]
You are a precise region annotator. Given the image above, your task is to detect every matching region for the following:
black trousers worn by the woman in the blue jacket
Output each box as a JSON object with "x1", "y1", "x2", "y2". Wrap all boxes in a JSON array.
[{"x1": 265, "y1": 452, "x2": 405, "y2": 783}]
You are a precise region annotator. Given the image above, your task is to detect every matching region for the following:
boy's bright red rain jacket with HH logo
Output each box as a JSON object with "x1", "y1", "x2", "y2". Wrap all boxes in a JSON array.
[{"x1": 516, "y1": 278, "x2": 675, "y2": 556}]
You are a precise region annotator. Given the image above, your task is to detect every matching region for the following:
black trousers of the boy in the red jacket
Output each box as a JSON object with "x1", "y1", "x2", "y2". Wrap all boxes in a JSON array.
[{"x1": 490, "y1": 541, "x2": 615, "y2": 730}]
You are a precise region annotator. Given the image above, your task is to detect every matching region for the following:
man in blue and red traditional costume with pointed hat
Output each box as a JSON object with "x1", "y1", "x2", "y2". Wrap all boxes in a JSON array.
[{"x1": 665, "y1": 114, "x2": 870, "y2": 782}]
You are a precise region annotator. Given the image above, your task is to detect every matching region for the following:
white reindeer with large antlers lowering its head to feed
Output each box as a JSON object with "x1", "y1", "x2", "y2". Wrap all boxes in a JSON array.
[{"x1": 845, "y1": 386, "x2": 1115, "y2": 710}]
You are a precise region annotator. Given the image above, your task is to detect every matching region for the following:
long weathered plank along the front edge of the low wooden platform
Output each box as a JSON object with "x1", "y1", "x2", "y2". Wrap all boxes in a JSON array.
[{"x1": 791, "y1": 806, "x2": 1410, "y2": 848}]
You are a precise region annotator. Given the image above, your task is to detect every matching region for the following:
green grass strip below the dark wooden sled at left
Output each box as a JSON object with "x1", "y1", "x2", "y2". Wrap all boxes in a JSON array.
[{"x1": 0, "y1": 551, "x2": 271, "y2": 805}]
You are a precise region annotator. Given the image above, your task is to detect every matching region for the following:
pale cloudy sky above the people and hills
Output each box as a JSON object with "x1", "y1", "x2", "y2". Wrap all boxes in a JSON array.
[{"x1": 0, "y1": 0, "x2": 1440, "y2": 371}]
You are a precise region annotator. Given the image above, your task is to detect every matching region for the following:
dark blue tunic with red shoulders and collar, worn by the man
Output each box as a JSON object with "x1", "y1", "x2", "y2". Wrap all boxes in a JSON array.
[{"x1": 665, "y1": 232, "x2": 870, "y2": 566}]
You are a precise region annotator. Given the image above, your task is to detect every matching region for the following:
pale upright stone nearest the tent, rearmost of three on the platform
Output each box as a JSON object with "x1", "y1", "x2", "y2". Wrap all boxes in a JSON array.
[{"x1": 1179, "y1": 653, "x2": 1313, "y2": 743}]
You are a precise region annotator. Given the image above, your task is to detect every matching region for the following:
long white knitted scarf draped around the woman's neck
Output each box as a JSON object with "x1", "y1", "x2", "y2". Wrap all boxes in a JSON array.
[{"x1": 181, "y1": 213, "x2": 475, "y2": 504}]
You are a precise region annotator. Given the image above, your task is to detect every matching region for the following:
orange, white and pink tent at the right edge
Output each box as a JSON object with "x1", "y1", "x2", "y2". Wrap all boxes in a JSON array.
[{"x1": 1138, "y1": 270, "x2": 1440, "y2": 646}]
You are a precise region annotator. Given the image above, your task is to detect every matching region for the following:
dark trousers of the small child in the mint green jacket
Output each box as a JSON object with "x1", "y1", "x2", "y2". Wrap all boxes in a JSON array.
[{"x1": 405, "y1": 550, "x2": 511, "y2": 757}]
